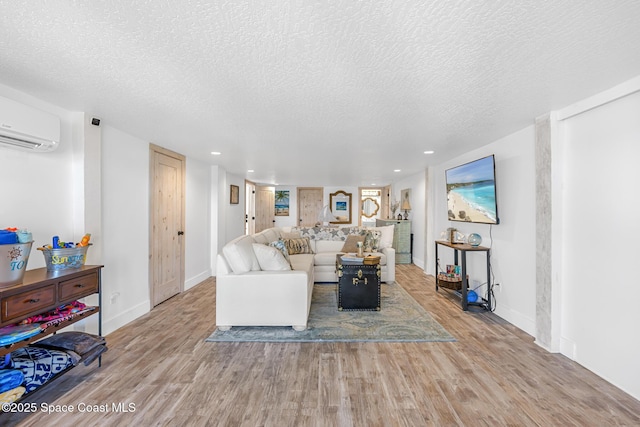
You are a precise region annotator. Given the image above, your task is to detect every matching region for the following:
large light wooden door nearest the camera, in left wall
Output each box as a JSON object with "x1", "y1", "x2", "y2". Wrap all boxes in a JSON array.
[{"x1": 149, "y1": 145, "x2": 186, "y2": 307}]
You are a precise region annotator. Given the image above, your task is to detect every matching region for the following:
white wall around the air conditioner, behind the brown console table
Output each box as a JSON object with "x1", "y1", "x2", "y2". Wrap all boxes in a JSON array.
[{"x1": 0, "y1": 85, "x2": 102, "y2": 333}]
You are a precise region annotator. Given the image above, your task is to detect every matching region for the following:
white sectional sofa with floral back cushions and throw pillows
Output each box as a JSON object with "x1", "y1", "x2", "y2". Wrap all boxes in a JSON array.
[{"x1": 216, "y1": 226, "x2": 395, "y2": 330}]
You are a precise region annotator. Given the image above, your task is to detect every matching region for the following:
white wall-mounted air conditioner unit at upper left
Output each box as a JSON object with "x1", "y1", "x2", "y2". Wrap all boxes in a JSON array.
[{"x1": 0, "y1": 97, "x2": 60, "y2": 152}]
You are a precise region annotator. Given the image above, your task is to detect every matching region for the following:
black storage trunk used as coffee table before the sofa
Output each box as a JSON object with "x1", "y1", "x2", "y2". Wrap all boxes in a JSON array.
[{"x1": 338, "y1": 261, "x2": 380, "y2": 311}]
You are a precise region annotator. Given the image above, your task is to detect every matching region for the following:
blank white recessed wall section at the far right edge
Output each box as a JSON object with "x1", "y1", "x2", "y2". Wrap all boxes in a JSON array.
[{"x1": 561, "y1": 88, "x2": 640, "y2": 398}]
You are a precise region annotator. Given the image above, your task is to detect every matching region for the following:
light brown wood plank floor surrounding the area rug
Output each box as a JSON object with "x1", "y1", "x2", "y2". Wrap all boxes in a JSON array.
[{"x1": 5, "y1": 265, "x2": 640, "y2": 426}]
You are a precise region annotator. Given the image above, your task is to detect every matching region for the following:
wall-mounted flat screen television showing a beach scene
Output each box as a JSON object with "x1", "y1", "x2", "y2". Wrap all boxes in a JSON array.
[{"x1": 445, "y1": 155, "x2": 499, "y2": 224}]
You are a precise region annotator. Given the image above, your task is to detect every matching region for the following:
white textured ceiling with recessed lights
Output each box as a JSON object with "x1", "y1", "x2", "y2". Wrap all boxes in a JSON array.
[{"x1": 0, "y1": 0, "x2": 640, "y2": 186}]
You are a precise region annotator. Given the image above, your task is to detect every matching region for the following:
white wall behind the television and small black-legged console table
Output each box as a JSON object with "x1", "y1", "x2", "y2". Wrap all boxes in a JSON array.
[{"x1": 428, "y1": 125, "x2": 536, "y2": 335}]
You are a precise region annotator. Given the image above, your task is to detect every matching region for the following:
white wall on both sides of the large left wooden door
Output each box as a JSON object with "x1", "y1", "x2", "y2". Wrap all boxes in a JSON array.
[{"x1": 89, "y1": 124, "x2": 211, "y2": 334}]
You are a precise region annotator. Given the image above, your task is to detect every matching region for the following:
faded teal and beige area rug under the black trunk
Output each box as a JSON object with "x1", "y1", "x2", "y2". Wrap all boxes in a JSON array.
[{"x1": 207, "y1": 283, "x2": 455, "y2": 342}]
